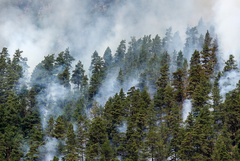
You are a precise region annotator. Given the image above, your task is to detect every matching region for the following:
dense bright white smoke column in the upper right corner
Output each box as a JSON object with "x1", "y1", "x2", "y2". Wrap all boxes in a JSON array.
[{"x1": 213, "y1": 0, "x2": 240, "y2": 60}]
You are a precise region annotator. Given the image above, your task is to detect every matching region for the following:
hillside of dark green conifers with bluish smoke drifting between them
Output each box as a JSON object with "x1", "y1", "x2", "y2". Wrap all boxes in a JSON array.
[{"x1": 0, "y1": 20, "x2": 240, "y2": 161}]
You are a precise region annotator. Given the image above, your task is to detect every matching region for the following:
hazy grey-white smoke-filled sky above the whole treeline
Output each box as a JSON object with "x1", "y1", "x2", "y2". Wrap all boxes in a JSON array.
[{"x1": 0, "y1": 0, "x2": 240, "y2": 71}]
